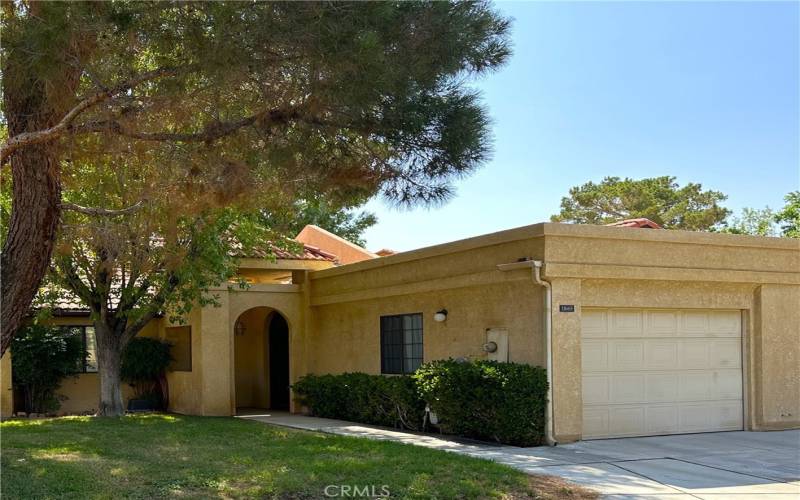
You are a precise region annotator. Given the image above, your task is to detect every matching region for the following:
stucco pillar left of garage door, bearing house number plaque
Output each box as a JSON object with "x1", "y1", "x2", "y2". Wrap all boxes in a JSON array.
[{"x1": 550, "y1": 278, "x2": 583, "y2": 443}]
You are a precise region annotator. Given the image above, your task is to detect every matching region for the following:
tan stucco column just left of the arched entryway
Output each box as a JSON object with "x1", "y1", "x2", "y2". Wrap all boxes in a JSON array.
[{"x1": 200, "y1": 290, "x2": 236, "y2": 416}]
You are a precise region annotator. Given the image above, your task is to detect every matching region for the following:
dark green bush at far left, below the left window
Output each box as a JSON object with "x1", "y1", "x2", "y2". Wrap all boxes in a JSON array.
[{"x1": 11, "y1": 325, "x2": 86, "y2": 413}]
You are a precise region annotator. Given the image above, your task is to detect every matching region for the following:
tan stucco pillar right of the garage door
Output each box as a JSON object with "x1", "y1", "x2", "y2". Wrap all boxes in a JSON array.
[{"x1": 748, "y1": 285, "x2": 800, "y2": 430}]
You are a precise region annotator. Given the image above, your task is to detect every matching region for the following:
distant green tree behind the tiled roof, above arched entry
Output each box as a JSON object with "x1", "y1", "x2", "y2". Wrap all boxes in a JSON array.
[{"x1": 261, "y1": 194, "x2": 378, "y2": 247}]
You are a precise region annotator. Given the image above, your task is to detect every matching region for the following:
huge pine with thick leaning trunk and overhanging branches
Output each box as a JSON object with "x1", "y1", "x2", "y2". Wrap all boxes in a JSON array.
[{"x1": 0, "y1": 1, "x2": 509, "y2": 352}]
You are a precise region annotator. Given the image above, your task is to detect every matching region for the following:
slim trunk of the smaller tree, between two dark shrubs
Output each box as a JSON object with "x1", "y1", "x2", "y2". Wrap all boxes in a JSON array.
[{"x1": 94, "y1": 321, "x2": 125, "y2": 417}]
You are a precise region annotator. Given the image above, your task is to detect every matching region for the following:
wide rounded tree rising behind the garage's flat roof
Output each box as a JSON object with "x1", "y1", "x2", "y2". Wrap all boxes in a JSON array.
[{"x1": 550, "y1": 176, "x2": 730, "y2": 231}]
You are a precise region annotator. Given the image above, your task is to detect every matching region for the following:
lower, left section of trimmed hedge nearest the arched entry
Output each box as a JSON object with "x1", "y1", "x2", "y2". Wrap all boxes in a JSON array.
[{"x1": 292, "y1": 373, "x2": 425, "y2": 430}]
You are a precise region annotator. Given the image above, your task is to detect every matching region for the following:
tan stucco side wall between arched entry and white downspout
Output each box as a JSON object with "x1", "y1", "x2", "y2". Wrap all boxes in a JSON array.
[{"x1": 307, "y1": 227, "x2": 544, "y2": 373}]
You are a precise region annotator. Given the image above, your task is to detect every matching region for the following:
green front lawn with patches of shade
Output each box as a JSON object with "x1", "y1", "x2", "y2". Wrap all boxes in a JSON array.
[{"x1": 0, "y1": 415, "x2": 591, "y2": 499}]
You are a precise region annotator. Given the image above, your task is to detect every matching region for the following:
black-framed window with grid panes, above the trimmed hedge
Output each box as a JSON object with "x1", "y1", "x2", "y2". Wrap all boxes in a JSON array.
[{"x1": 381, "y1": 313, "x2": 422, "y2": 374}]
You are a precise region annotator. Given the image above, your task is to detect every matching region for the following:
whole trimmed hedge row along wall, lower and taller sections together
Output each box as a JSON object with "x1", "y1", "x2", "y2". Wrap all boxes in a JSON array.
[{"x1": 293, "y1": 359, "x2": 547, "y2": 446}]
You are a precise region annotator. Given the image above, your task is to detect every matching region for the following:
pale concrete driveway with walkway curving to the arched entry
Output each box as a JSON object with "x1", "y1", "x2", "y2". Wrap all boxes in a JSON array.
[{"x1": 240, "y1": 412, "x2": 800, "y2": 500}]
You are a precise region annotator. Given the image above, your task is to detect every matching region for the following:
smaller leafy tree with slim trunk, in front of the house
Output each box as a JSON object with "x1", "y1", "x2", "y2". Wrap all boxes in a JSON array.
[{"x1": 49, "y1": 155, "x2": 290, "y2": 416}]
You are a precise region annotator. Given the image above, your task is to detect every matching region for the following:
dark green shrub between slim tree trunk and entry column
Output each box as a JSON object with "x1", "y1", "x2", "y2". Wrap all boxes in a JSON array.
[{"x1": 120, "y1": 337, "x2": 172, "y2": 407}]
